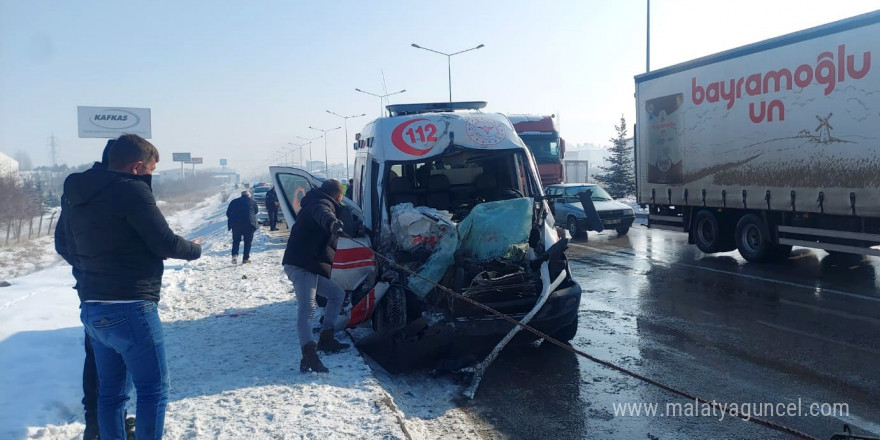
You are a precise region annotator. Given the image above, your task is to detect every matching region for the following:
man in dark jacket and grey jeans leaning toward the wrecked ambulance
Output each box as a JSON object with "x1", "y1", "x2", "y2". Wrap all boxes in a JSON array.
[{"x1": 282, "y1": 179, "x2": 348, "y2": 373}]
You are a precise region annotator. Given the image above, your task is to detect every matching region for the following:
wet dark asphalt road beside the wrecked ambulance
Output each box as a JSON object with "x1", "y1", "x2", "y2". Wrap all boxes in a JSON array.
[{"x1": 467, "y1": 225, "x2": 880, "y2": 440}]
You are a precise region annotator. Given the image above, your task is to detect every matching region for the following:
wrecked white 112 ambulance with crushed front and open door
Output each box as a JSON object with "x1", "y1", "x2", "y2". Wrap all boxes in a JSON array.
[{"x1": 270, "y1": 102, "x2": 581, "y2": 370}]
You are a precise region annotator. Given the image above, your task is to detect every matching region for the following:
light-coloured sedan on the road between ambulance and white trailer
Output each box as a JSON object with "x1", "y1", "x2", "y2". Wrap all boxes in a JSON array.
[{"x1": 544, "y1": 183, "x2": 636, "y2": 237}]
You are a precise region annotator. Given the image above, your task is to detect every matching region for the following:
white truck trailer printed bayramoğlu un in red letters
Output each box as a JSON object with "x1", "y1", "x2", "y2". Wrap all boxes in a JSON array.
[{"x1": 635, "y1": 11, "x2": 880, "y2": 262}]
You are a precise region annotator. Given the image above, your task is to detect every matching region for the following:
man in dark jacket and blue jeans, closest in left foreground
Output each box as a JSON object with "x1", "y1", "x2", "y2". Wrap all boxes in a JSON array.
[{"x1": 56, "y1": 135, "x2": 201, "y2": 440}]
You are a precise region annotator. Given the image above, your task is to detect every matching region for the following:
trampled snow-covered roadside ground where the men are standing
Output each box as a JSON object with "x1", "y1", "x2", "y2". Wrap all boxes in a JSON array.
[{"x1": 0, "y1": 196, "x2": 485, "y2": 439}]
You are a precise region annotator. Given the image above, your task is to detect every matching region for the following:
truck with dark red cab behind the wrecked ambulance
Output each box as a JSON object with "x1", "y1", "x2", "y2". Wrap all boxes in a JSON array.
[{"x1": 507, "y1": 115, "x2": 565, "y2": 186}]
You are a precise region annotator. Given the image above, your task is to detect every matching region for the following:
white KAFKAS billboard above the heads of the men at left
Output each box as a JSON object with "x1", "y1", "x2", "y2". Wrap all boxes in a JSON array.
[{"x1": 76, "y1": 106, "x2": 153, "y2": 139}]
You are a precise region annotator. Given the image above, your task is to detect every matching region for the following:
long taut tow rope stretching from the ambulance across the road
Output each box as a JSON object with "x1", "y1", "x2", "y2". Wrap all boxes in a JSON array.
[{"x1": 340, "y1": 233, "x2": 860, "y2": 440}]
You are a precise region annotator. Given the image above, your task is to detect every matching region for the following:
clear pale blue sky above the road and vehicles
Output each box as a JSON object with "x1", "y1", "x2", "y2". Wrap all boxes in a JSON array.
[{"x1": 0, "y1": 0, "x2": 880, "y2": 174}]
